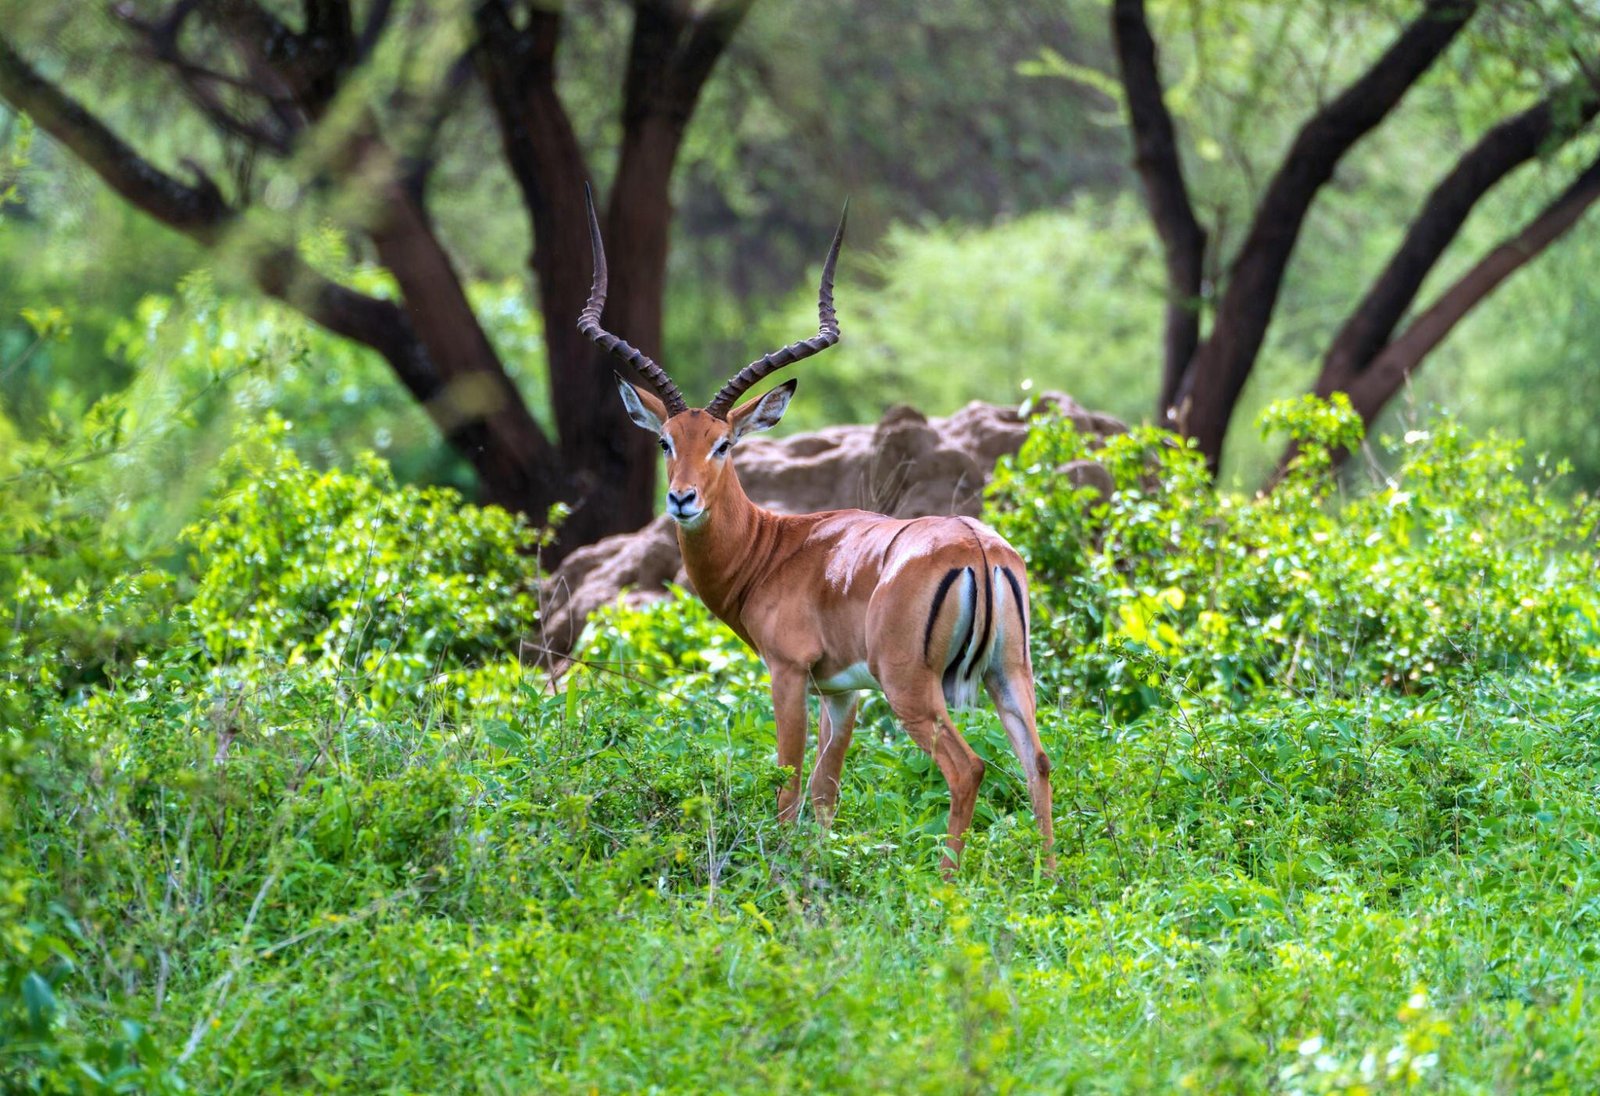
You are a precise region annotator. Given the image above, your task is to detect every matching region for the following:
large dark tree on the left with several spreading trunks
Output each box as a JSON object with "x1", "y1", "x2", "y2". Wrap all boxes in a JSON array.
[{"x1": 0, "y1": 0, "x2": 750, "y2": 558}]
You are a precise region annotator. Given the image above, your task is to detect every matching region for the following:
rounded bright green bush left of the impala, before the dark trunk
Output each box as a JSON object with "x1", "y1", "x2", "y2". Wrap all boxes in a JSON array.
[{"x1": 184, "y1": 422, "x2": 538, "y2": 706}]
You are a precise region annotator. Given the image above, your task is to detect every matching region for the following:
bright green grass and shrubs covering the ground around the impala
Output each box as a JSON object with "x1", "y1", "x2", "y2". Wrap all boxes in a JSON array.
[{"x1": 9, "y1": 380, "x2": 1600, "y2": 1093}]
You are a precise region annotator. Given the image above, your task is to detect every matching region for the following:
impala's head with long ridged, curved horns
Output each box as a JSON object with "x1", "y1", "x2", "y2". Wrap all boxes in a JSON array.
[{"x1": 578, "y1": 185, "x2": 845, "y2": 528}]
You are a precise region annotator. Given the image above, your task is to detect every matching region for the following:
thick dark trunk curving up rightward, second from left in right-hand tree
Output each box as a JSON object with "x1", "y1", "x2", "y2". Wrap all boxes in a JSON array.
[{"x1": 1178, "y1": 0, "x2": 1478, "y2": 470}]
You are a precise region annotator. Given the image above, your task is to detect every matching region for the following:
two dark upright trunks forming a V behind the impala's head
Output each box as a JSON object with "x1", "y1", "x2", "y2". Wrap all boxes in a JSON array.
[{"x1": 477, "y1": 0, "x2": 750, "y2": 544}]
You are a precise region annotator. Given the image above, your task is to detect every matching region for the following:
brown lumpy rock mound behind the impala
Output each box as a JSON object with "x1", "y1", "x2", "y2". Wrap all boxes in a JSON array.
[{"x1": 536, "y1": 392, "x2": 1126, "y2": 661}]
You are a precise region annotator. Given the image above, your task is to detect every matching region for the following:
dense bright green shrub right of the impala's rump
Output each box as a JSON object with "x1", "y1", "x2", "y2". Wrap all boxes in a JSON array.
[{"x1": 990, "y1": 400, "x2": 1600, "y2": 717}]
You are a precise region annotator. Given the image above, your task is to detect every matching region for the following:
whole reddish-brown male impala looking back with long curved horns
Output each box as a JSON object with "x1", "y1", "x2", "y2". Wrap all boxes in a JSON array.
[{"x1": 578, "y1": 192, "x2": 1054, "y2": 870}]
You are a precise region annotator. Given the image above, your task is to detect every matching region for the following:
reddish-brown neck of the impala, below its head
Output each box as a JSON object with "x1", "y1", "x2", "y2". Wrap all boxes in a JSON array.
[{"x1": 678, "y1": 467, "x2": 776, "y2": 643}]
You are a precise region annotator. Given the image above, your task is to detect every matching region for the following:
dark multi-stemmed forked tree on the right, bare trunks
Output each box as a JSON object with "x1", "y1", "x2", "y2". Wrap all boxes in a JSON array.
[{"x1": 1110, "y1": 0, "x2": 1600, "y2": 472}]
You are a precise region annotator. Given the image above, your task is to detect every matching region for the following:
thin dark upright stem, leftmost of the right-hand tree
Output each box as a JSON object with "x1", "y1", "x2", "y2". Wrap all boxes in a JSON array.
[{"x1": 1110, "y1": 0, "x2": 1206, "y2": 424}]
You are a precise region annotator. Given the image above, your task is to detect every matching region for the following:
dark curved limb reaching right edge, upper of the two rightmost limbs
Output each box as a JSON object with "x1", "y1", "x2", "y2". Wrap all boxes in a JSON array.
[{"x1": 1315, "y1": 80, "x2": 1600, "y2": 397}]
